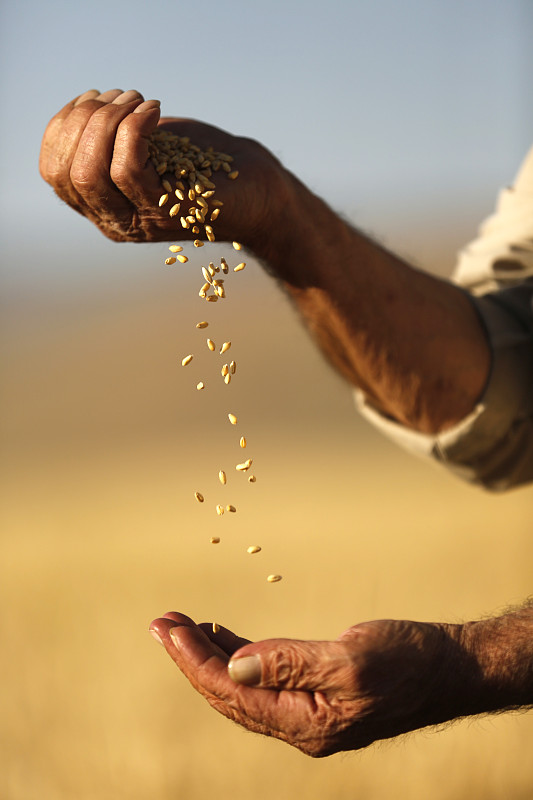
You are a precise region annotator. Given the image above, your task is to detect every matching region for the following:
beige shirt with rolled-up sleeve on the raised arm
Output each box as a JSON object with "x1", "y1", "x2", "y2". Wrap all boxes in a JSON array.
[{"x1": 356, "y1": 148, "x2": 533, "y2": 491}]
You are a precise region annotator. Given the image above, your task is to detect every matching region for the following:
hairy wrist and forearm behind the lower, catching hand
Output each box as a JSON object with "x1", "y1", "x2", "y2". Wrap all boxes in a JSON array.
[{"x1": 360, "y1": 602, "x2": 533, "y2": 741}]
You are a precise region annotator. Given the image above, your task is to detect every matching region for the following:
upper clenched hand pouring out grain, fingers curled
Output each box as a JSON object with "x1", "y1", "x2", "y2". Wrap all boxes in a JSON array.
[{"x1": 39, "y1": 89, "x2": 288, "y2": 245}]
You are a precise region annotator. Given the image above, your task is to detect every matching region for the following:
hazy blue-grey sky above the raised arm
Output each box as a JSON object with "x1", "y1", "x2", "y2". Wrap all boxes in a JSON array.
[{"x1": 0, "y1": 0, "x2": 533, "y2": 282}]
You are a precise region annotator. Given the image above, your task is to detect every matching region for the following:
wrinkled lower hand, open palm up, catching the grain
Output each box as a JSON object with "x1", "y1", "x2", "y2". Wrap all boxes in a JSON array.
[{"x1": 150, "y1": 612, "x2": 465, "y2": 757}]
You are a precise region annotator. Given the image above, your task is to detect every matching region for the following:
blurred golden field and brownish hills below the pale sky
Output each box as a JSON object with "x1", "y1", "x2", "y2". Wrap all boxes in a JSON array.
[{"x1": 0, "y1": 246, "x2": 533, "y2": 800}]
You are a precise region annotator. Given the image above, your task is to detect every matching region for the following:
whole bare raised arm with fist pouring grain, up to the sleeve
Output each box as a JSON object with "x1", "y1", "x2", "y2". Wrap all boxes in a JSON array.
[{"x1": 40, "y1": 96, "x2": 490, "y2": 433}]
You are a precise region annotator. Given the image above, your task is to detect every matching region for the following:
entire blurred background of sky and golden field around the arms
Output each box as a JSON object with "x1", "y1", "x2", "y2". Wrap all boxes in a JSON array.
[{"x1": 0, "y1": 0, "x2": 533, "y2": 800}]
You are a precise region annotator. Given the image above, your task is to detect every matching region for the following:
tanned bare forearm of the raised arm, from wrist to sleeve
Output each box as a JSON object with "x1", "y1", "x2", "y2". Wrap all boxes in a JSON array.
[{"x1": 250, "y1": 175, "x2": 490, "y2": 433}]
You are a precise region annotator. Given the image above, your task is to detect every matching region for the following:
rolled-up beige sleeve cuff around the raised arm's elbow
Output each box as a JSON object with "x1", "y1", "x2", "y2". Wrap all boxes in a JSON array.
[{"x1": 356, "y1": 282, "x2": 533, "y2": 491}]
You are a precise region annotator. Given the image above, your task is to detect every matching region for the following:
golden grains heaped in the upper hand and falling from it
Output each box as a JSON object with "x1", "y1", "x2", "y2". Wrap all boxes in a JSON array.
[{"x1": 148, "y1": 128, "x2": 281, "y2": 600}]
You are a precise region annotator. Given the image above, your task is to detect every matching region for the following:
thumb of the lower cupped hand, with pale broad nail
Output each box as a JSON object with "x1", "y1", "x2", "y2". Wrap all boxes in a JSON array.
[{"x1": 228, "y1": 639, "x2": 354, "y2": 692}]
